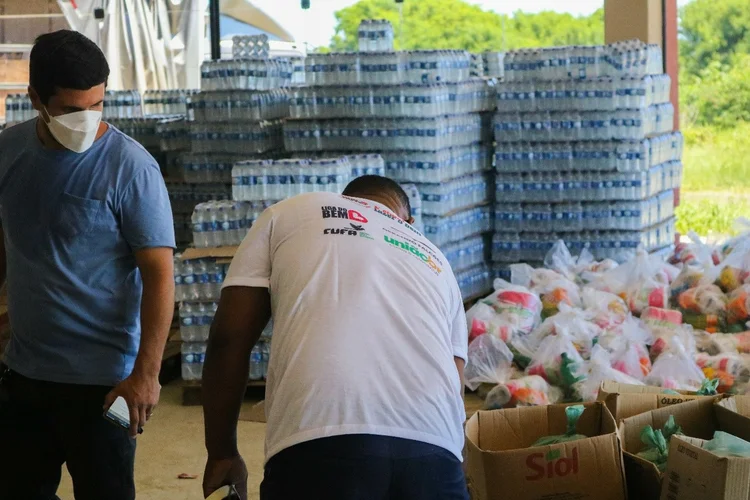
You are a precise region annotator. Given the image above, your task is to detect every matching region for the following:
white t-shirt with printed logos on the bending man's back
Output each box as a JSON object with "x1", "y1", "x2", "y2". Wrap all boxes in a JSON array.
[{"x1": 224, "y1": 193, "x2": 468, "y2": 460}]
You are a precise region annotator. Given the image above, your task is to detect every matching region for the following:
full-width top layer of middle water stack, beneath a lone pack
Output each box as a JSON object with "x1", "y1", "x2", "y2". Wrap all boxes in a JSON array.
[{"x1": 305, "y1": 50, "x2": 471, "y2": 85}]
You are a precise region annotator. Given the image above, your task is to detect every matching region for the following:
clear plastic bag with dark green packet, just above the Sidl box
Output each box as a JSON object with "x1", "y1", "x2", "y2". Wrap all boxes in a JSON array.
[{"x1": 526, "y1": 329, "x2": 583, "y2": 388}]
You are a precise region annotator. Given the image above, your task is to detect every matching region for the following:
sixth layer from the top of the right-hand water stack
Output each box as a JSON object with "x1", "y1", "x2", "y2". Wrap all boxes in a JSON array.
[{"x1": 495, "y1": 190, "x2": 675, "y2": 232}]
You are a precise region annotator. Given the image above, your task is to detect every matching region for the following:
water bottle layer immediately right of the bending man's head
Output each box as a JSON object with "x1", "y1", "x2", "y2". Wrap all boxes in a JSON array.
[{"x1": 417, "y1": 173, "x2": 490, "y2": 215}]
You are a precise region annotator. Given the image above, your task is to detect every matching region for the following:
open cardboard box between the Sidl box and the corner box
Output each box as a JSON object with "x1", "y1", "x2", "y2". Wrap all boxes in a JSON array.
[{"x1": 620, "y1": 396, "x2": 750, "y2": 500}]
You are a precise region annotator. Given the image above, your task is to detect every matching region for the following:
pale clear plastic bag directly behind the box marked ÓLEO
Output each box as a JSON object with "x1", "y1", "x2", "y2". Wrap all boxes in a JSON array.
[{"x1": 646, "y1": 337, "x2": 706, "y2": 391}]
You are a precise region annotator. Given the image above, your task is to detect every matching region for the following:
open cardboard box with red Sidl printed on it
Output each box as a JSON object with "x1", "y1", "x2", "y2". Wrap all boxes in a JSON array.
[{"x1": 465, "y1": 403, "x2": 626, "y2": 500}]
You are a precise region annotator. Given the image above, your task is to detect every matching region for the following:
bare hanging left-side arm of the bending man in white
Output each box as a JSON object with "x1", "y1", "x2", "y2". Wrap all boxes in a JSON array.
[{"x1": 202, "y1": 286, "x2": 271, "y2": 498}]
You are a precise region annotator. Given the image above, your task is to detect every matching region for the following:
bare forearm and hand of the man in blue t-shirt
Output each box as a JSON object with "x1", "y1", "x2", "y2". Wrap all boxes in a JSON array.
[{"x1": 105, "y1": 248, "x2": 174, "y2": 437}]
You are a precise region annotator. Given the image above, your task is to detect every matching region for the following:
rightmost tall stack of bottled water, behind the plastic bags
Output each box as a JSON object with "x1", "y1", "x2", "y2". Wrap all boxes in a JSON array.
[{"x1": 493, "y1": 42, "x2": 682, "y2": 280}]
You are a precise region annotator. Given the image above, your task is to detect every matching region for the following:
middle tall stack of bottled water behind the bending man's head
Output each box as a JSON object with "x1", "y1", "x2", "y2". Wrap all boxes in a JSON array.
[{"x1": 284, "y1": 51, "x2": 500, "y2": 296}]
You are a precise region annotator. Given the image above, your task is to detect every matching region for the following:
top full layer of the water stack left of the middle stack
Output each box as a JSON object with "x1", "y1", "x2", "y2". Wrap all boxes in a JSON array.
[{"x1": 201, "y1": 58, "x2": 294, "y2": 91}]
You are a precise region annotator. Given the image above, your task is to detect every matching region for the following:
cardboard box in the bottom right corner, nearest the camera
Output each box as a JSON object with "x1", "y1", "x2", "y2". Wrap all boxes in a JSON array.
[{"x1": 661, "y1": 436, "x2": 750, "y2": 500}]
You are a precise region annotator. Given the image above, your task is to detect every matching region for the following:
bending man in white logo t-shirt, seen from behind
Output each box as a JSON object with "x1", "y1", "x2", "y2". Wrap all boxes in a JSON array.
[{"x1": 203, "y1": 176, "x2": 468, "y2": 500}]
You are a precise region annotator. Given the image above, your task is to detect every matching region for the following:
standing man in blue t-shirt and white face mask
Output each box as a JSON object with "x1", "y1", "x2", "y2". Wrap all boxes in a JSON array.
[{"x1": 0, "y1": 31, "x2": 175, "y2": 500}]
